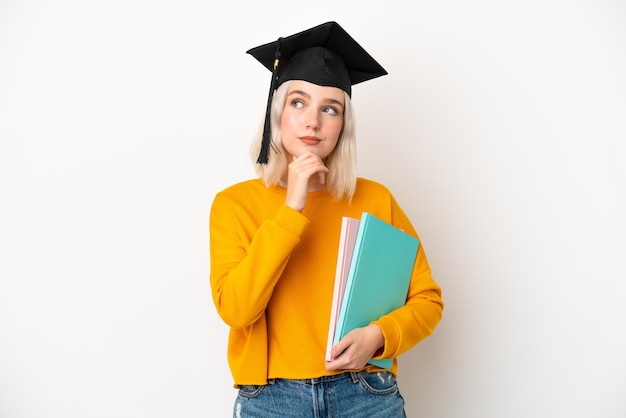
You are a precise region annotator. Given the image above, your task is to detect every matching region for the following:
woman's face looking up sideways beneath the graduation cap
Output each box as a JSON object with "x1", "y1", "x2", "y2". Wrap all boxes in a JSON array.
[{"x1": 280, "y1": 80, "x2": 345, "y2": 161}]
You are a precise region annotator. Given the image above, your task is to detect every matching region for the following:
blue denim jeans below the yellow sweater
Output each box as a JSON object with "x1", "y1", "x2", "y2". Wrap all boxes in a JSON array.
[{"x1": 233, "y1": 372, "x2": 406, "y2": 418}]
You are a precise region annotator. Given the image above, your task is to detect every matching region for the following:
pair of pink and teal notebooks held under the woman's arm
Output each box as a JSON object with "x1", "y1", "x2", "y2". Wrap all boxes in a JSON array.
[{"x1": 326, "y1": 212, "x2": 419, "y2": 369}]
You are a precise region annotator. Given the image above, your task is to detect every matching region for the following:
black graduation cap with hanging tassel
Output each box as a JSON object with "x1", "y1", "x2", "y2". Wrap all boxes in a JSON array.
[{"x1": 247, "y1": 22, "x2": 387, "y2": 164}]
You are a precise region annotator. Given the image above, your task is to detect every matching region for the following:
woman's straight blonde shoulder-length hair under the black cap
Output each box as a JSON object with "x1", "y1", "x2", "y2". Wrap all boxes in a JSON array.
[{"x1": 250, "y1": 81, "x2": 356, "y2": 201}]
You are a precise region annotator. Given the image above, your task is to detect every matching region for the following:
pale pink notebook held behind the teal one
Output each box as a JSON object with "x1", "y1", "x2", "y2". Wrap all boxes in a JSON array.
[{"x1": 326, "y1": 216, "x2": 360, "y2": 361}]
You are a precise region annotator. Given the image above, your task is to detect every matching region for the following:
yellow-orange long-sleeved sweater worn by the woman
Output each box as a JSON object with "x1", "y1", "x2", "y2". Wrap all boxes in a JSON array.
[{"x1": 209, "y1": 178, "x2": 443, "y2": 386}]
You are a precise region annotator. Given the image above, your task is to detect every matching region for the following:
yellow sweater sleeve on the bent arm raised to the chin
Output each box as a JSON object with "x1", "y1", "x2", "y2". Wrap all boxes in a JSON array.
[{"x1": 209, "y1": 194, "x2": 309, "y2": 328}]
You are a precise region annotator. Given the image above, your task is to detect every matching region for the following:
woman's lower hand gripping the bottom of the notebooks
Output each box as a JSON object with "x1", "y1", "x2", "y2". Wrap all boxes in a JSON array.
[{"x1": 326, "y1": 324, "x2": 385, "y2": 370}]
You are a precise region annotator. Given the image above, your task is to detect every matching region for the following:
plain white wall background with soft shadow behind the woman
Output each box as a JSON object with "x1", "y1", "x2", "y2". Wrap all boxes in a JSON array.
[{"x1": 0, "y1": 0, "x2": 626, "y2": 418}]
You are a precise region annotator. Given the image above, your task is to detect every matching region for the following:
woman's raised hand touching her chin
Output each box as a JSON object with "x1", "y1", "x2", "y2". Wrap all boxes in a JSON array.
[{"x1": 285, "y1": 151, "x2": 328, "y2": 212}]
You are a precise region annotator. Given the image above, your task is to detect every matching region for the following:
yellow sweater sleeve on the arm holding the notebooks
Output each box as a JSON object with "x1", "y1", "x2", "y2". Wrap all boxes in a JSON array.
[{"x1": 374, "y1": 197, "x2": 444, "y2": 358}]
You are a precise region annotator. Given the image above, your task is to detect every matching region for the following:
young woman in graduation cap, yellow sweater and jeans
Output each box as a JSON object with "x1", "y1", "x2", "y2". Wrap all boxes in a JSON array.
[{"x1": 210, "y1": 22, "x2": 443, "y2": 418}]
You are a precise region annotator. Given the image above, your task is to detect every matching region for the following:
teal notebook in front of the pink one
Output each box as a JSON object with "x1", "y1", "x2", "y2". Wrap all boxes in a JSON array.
[{"x1": 333, "y1": 212, "x2": 419, "y2": 369}]
